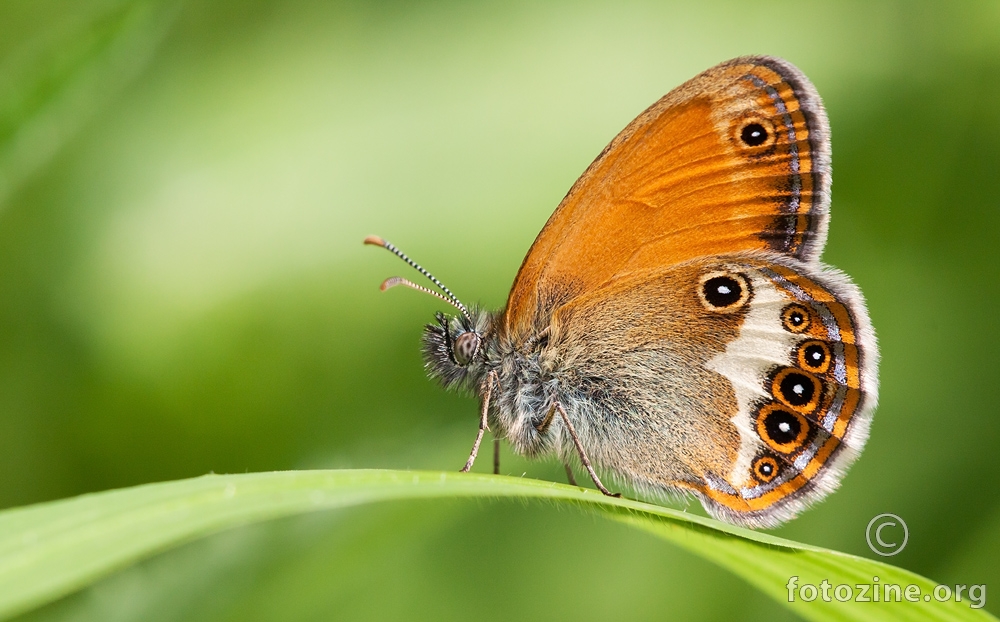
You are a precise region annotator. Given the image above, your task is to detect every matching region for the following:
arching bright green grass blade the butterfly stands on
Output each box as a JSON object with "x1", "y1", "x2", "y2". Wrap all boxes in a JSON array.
[{"x1": 0, "y1": 470, "x2": 995, "y2": 620}]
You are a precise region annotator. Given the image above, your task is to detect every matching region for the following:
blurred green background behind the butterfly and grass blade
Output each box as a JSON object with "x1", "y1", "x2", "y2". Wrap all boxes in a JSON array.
[{"x1": 0, "y1": 0, "x2": 1000, "y2": 621}]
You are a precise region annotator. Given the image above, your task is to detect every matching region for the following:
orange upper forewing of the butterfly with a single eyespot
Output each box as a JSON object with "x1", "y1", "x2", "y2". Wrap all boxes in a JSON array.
[{"x1": 503, "y1": 56, "x2": 830, "y2": 343}]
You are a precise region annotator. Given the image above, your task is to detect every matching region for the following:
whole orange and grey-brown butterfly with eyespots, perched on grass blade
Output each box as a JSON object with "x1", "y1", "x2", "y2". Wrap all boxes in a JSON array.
[{"x1": 365, "y1": 56, "x2": 878, "y2": 528}]
